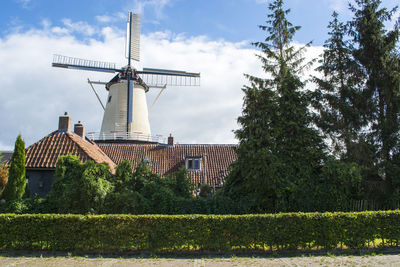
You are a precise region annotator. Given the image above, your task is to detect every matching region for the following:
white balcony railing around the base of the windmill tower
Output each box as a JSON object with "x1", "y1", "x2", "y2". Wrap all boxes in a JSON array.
[{"x1": 86, "y1": 132, "x2": 165, "y2": 143}]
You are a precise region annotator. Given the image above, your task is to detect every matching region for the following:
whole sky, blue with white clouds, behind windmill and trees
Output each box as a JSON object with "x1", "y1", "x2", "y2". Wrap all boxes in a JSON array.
[{"x1": 0, "y1": 0, "x2": 397, "y2": 150}]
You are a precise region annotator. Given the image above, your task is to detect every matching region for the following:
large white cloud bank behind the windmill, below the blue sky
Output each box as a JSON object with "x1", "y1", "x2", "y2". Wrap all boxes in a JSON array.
[{"x1": 0, "y1": 18, "x2": 321, "y2": 149}]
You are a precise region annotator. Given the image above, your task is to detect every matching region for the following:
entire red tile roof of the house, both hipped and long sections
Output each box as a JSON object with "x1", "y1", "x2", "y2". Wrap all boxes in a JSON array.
[{"x1": 26, "y1": 131, "x2": 237, "y2": 186}]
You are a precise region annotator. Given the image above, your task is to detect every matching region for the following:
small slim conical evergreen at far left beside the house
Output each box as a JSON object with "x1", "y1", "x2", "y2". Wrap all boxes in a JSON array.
[{"x1": 3, "y1": 135, "x2": 26, "y2": 201}]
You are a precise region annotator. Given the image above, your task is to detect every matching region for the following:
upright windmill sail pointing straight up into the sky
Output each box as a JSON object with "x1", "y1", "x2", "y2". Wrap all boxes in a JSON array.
[{"x1": 125, "y1": 13, "x2": 141, "y2": 61}]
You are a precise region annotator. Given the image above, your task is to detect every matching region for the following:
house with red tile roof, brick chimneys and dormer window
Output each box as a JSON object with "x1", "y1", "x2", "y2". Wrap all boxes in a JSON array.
[{"x1": 25, "y1": 113, "x2": 237, "y2": 197}]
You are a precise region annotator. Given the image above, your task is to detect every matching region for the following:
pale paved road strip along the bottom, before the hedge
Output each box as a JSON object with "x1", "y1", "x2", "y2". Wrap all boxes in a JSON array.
[{"x1": 0, "y1": 255, "x2": 400, "y2": 267}]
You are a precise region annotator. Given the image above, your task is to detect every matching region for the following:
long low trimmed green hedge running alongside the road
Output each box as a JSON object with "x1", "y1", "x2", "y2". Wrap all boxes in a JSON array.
[{"x1": 0, "y1": 213, "x2": 400, "y2": 251}]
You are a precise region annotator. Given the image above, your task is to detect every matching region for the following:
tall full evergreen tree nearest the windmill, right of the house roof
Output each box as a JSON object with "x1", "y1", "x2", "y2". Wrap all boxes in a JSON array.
[{"x1": 224, "y1": 0, "x2": 324, "y2": 214}]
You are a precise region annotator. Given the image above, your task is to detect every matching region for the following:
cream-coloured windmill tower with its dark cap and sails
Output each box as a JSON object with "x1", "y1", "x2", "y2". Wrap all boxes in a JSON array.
[{"x1": 52, "y1": 12, "x2": 200, "y2": 141}]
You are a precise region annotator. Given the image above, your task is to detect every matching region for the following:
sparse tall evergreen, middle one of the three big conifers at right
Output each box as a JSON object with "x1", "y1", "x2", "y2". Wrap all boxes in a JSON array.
[{"x1": 312, "y1": 12, "x2": 366, "y2": 159}]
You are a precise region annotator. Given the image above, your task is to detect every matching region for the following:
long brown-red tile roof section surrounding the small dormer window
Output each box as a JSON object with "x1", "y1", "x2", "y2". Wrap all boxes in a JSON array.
[{"x1": 97, "y1": 143, "x2": 237, "y2": 186}]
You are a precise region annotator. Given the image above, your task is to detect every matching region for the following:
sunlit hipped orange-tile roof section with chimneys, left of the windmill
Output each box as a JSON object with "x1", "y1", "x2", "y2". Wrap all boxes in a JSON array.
[{"x1": 25, "y1": 131, "x2": 115, "y2": 172}]
